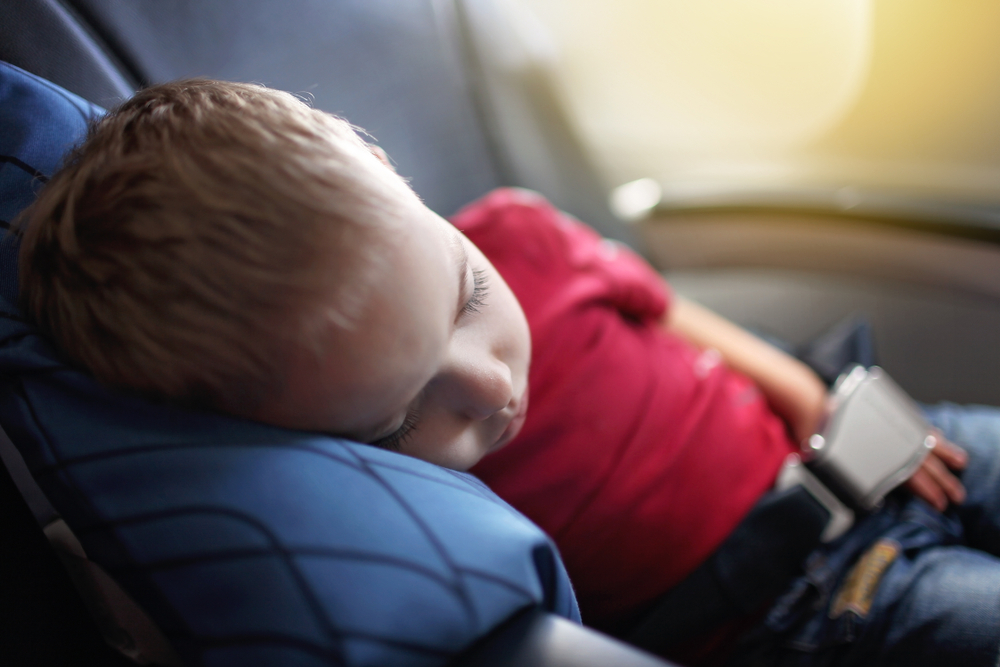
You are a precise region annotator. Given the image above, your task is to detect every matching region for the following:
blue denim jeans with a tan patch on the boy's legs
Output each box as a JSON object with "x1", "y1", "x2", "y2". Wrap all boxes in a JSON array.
[{"x1": 732, "y1": 404, "x2": 1000, "y2": 667}]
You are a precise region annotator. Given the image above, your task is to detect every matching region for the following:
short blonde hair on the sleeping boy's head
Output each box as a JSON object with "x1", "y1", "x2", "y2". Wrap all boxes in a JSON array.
[{"x1": 18, "y1": 79, "x2": 392, "y2": 416}]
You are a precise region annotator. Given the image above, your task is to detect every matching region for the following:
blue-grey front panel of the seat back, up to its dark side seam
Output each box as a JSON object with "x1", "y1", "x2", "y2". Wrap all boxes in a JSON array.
[{"x1": 0, "y1": 0, "x2": 502, "y2": 215}]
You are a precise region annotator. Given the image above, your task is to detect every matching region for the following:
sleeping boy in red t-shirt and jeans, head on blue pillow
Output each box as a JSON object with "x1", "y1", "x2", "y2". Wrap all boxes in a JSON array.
[{"x1": 19, "y1": 80, "x2": 1000, "y2": 666}]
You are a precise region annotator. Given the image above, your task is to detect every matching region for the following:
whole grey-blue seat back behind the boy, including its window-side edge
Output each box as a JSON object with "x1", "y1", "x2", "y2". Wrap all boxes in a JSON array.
[{"x1": 0, "y1": 0, "x2": 637, "y2": 247}]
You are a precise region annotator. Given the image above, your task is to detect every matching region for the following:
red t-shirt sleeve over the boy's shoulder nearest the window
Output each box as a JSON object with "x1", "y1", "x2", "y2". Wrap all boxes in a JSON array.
[{"x1": 452, "y1": 188, "x2": 671, "y2": 320}]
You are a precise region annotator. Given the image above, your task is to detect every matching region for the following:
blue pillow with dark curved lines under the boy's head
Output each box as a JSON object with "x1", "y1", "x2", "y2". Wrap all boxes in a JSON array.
[{"x1": 0, "y1": 63, "x2": 579, "y2": 667}]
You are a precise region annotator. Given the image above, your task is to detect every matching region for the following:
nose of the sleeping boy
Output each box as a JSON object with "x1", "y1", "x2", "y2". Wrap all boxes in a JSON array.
[{"x1": 448, "y1": 355, "x2": 514, "y2": 420}]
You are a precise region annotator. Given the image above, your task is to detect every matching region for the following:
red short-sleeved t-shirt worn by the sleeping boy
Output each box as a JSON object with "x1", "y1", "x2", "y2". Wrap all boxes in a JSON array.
[{"x1": 453, "y1": 189, "x2": 792, "y2": 627}]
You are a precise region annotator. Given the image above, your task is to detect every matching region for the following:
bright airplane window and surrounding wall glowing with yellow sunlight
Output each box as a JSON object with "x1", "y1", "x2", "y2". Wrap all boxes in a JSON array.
[{"x1": 510, "y1": 0, "x2": 1000, "y2": 226}]
